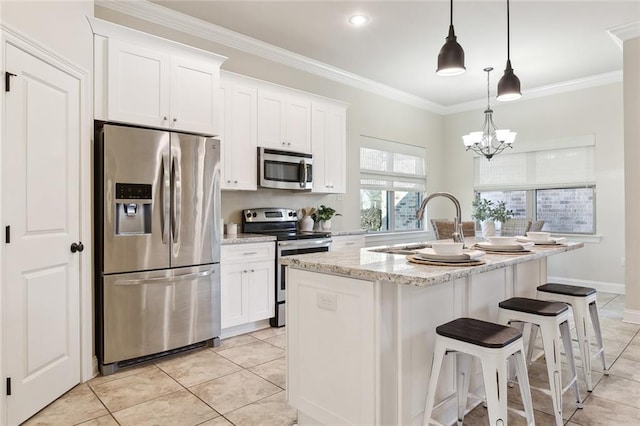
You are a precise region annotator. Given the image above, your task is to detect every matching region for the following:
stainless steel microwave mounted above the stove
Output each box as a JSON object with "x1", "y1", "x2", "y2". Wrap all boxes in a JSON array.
[{"x1": 258, "y1": 148, "x2": 313, "y2": 190}]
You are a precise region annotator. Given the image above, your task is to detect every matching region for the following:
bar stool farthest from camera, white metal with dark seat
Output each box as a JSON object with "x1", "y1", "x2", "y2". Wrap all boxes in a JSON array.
[{"x1": 536, "y1": 283, "x2": 609, "y2": 392}]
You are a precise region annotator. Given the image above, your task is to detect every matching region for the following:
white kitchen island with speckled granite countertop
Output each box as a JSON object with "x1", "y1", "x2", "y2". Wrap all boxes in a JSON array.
[{"x1": 281, "y1": 243, "x2": 583, "y2": 425}]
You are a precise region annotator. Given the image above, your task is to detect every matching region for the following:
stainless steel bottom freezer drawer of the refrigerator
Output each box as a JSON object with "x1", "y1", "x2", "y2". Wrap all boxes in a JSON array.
[{"x1": 101, "y1": 263, "x2": 220, "y2": 364}]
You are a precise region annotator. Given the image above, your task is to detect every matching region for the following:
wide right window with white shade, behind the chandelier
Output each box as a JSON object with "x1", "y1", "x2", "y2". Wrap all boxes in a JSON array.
[{"x1": 474, "y1": 135, "x2": 596, "y2": 234}]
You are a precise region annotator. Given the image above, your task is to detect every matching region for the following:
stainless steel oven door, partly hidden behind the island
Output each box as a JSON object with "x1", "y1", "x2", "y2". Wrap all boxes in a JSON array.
[{"x1": 271, "y1": 238, "x2": 331, "y2": 327}]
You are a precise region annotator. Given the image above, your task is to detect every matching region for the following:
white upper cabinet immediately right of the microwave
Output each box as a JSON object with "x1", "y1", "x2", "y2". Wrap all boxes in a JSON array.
[{"x1": 311, "y1": 101, "x2": 347, "y2": 193}]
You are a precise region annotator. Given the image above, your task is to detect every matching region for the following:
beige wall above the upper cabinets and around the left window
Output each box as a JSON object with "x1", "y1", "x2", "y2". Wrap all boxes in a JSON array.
[{"x1": 95, "y1": 6, "x2": 453, "y2": 230}]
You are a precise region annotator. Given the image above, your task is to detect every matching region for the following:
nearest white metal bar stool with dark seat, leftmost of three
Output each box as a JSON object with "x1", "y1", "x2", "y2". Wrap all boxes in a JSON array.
[{"x1": 423, "y1": 318, "x2": 534, "y2": 426}]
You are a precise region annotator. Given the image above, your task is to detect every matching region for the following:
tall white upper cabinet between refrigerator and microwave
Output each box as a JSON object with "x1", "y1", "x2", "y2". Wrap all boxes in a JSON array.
[{"x1": 217, "y1": 78, "x2": 258, "y2": 190}]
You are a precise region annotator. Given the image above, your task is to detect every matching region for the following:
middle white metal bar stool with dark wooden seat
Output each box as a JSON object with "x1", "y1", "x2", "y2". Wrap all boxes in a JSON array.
[{"x1": 498, "y1": 297, "x2": 582, "y2": 425}]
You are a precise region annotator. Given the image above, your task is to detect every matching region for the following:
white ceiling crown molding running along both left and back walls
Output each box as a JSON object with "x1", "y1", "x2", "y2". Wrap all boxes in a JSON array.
[{"x1": 95, "y1": 0, "x2": 624, "y2": 115}]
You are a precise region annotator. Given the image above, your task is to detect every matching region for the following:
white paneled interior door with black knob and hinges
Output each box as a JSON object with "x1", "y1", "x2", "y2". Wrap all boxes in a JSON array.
[{"x1": 2, "y1": 44, "x2": 81, "y2": 425}]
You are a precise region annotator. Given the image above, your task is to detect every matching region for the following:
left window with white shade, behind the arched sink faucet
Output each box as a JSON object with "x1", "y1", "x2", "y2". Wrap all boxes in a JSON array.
[{"x1": 360, "y1": 136, "x2": 426, "y2": 232}]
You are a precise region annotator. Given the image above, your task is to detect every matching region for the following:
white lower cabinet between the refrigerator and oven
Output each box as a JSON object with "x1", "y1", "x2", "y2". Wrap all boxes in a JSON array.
[{"x1": 220, "y1": 242, "x2": 275, "y2": 329}]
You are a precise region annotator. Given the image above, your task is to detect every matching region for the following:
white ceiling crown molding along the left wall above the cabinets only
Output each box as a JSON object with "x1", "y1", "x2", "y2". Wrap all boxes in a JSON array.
[{"x1": 95, "y1": 0, "x2": 444, "y2": 114}]
